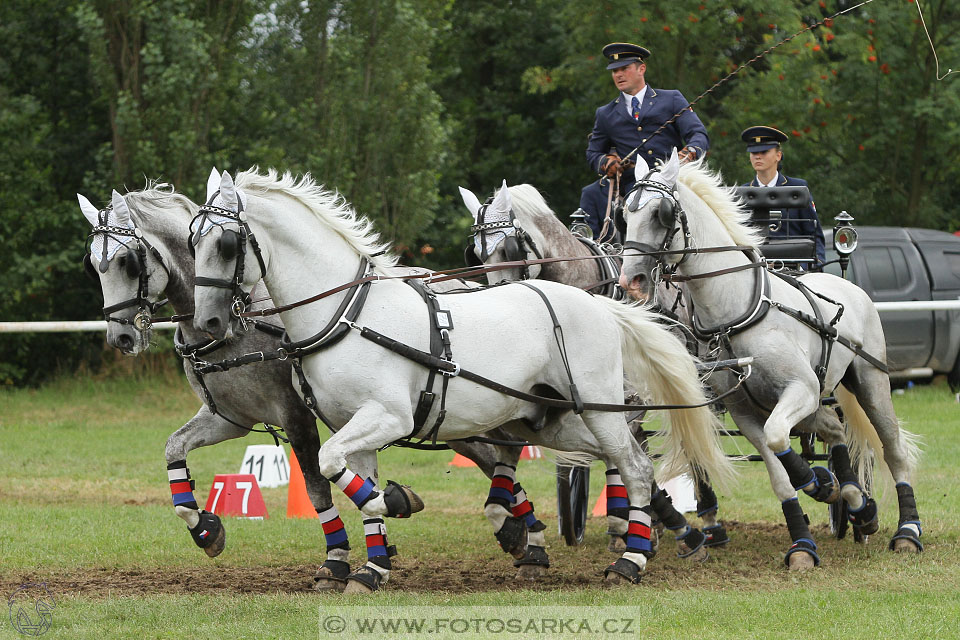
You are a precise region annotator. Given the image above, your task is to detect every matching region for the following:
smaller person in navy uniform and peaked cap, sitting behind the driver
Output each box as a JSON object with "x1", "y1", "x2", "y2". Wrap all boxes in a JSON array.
[{"x1": 740, "y1": 126, "x2": 826, "y2": 264}]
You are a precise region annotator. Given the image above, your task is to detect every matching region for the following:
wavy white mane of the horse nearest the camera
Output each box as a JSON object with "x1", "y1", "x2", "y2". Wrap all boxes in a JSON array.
[{"x1": 235, "y1": 166, "x2": 397, "y2": 269}]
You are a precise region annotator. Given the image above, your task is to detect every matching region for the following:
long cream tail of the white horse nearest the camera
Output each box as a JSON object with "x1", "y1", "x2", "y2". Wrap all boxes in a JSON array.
[{"x1": 594, "y1": 297, "x2": 736, "y2": 486}]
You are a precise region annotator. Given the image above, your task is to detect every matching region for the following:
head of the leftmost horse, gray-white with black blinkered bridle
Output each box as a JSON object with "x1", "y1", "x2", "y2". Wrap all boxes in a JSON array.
[{"x1": 77, "y1": 191, "x2": 170, "y2": 355}]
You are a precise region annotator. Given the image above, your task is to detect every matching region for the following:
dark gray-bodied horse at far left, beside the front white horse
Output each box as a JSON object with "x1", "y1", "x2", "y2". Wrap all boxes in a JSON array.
[{"x1": 78, "y1": 183, "x2": 549, "y2": 591}]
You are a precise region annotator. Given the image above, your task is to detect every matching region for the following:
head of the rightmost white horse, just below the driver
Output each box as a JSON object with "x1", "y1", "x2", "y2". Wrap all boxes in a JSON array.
[{"x1": 617, "y1": 149, "x2": 685, "y2": 300}]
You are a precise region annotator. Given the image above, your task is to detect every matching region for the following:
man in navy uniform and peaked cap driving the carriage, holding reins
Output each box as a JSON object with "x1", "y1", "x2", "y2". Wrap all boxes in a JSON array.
[{"x1": 580, "y1": 42, "x2": 710, "y2": 241}]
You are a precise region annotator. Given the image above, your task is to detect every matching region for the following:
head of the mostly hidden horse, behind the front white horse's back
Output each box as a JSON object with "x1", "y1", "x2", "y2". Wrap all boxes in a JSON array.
[{"x1": 460, "y1": 180, "x2": 540, "y2": 284}]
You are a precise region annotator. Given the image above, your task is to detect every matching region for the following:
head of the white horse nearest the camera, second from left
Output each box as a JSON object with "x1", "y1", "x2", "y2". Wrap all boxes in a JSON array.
[{"x1": 187, "y1": 170, "x2": 265, "y2": 340}]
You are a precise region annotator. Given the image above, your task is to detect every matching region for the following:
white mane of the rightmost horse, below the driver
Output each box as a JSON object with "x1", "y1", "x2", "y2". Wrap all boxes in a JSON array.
[{"x1": 677, "y1": 159, "x2": 763, "y2": 247}]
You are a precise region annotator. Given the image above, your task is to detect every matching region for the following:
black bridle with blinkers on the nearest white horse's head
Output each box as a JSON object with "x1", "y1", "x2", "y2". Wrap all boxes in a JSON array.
[{"x1": 187, "y1": 191, "x2": 267, "y2": 321}]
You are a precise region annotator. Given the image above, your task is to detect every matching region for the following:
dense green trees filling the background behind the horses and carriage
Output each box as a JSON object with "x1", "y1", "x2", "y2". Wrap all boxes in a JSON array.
[{"x1": 0, "y1": 0, "x2": 960, "y2": 383}]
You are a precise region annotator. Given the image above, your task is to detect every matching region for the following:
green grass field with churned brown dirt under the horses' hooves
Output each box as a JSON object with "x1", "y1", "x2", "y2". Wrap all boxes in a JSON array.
[{"x1": 0, "y1": 364, "x2": 960, "y2": 639}]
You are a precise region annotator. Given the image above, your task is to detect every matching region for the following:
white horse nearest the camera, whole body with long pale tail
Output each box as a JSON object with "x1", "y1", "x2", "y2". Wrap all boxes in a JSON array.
[{"x1": 191, "y1": 171, "x2": 729, "y2": 582}]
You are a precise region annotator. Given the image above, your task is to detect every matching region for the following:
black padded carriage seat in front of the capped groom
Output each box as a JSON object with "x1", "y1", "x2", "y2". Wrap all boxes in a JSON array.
[{"x1": 736, "y1": 187, "x2": 817, "y2": 267}]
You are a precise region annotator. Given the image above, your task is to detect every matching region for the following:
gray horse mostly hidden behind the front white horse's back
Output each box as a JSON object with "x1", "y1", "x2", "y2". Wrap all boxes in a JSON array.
[{"x1": 460, "y1": 182, "x2": 729, "y2": 560}]
